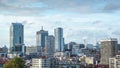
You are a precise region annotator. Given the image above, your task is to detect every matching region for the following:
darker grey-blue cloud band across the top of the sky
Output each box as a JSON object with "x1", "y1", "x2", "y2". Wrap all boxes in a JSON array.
[{"x1": 0, "y1": 0, "x2": 120, "y2": 16}]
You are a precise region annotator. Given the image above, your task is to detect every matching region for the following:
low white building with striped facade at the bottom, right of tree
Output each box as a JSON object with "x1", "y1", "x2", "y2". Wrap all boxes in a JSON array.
[{"x1": 30, "y1": 58, "x2": 51, "y2": 68}]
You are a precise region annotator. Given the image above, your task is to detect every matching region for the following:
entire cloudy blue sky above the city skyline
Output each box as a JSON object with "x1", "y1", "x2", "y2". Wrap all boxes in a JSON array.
[{"x1": 0, "y1": 0, "x2": 120, "y2": 47}]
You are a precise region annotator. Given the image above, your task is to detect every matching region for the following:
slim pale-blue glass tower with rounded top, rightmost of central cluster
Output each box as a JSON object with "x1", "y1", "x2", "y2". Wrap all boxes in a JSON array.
[{"x1": 54, "y1": 28, "x2": 64, "y2": 52}]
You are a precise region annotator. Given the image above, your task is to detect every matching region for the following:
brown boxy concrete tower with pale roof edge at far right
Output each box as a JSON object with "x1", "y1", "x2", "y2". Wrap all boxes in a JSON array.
[{"x1": 100, "y1": 38, "x2": 118, "y2": 64}]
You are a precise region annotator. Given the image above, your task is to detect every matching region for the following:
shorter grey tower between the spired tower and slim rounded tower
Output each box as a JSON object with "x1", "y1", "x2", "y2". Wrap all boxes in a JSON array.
[{"x1": 45, "y1": 35, "x2": 55, "y2": 57}]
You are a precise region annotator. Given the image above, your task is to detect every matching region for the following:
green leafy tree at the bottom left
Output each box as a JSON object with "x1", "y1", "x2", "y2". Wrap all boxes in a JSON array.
[{"x1": 3, "y1": 57, "x2": 25, "y2": 68}]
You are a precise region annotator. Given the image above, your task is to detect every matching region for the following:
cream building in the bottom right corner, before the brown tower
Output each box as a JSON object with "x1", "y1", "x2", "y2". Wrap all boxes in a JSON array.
[{"x1": 109, "y1": 55, "x2": 120, "y2": 68}]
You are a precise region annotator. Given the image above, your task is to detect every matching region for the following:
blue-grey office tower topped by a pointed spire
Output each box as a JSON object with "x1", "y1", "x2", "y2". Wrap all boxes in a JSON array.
[{"x1": 36, "y1": 27, "x2": 48, "y2": 48}]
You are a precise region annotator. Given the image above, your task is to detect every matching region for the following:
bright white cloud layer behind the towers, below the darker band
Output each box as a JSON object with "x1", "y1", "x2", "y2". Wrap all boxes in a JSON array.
[{"x1": 0, "y1": 9, "x2": 120, "y2": 45}]
